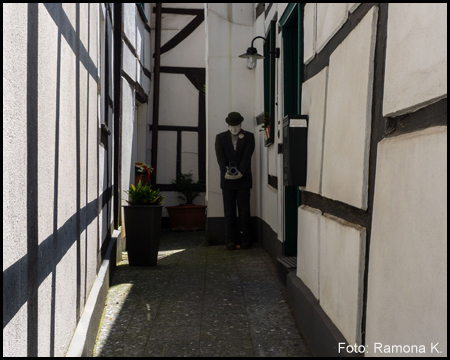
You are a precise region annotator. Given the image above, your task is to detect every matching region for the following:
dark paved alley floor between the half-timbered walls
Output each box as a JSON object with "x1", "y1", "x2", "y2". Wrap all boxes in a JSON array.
[{"x1": 94, "y1": 231, "x2": 309, "y2": 356}]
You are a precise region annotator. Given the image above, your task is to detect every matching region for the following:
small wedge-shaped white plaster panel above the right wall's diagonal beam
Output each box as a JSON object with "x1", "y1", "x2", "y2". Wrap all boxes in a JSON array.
[{"x1": 316, "y1": 3, "x2": 348, "y2": 53}]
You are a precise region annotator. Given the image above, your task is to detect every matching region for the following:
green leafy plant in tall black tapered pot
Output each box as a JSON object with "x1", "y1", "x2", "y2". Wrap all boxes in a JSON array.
[{"x1": 123, "y1": 181, "x2": 164, "y2": 266}]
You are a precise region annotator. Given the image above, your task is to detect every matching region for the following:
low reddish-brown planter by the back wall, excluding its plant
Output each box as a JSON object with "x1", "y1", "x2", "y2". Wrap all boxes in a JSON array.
[{"x1": 166, "y1": 204, "x2": 206, "y2": 231}]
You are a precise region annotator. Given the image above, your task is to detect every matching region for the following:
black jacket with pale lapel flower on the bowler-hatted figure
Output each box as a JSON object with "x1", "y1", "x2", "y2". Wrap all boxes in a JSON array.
[{"x1": 215, "y1": 130, "x2": 255, "y2": 189}]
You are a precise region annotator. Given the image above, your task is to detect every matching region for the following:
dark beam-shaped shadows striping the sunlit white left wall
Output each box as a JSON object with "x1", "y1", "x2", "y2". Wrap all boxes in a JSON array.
[{"x1": 3, "y1": 3, "x2": 103, "y2": 356}]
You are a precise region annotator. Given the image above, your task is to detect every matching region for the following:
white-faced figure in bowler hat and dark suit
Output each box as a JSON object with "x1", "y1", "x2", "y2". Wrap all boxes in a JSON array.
[{"x1": 215, "y1": 112, "x2": 255, "y2": 250}]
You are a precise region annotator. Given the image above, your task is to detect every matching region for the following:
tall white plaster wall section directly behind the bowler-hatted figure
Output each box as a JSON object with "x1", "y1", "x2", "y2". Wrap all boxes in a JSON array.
[{"x1": 206, "y1": 3, "x2": 255, "y2": 217}]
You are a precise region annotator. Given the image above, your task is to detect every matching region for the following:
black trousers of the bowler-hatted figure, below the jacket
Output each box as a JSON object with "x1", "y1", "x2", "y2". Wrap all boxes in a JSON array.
[{"x1": 222, "y1": 189, "x2": 252, "y2": 244}]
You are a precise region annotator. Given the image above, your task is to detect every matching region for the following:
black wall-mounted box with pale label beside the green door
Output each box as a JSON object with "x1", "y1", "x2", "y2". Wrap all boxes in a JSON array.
[{"x1": 283, "y1": 115, "x2": 308, "y2": 186}]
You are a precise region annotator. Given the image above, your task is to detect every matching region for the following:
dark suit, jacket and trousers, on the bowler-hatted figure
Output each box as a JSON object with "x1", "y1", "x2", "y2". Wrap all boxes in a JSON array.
[{"x1": 215, "y1": 130, "x2": 255, "y2": 244}]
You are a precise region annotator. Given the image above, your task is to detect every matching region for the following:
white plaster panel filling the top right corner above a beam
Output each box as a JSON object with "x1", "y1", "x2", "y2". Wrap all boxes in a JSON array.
[{"x1": 383, "y1": 3, "x2": 447, "y2": 116}]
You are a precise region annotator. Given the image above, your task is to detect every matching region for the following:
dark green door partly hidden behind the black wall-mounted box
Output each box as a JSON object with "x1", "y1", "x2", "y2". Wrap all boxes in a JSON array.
[{"x1": 280, "y1": 3, "x2": 303, "y2": 256}]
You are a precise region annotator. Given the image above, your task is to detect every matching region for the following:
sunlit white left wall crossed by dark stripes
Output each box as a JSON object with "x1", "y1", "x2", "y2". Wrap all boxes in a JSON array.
[{"x1": 3, "y1": 4, "x2": 98, "y2": 356}]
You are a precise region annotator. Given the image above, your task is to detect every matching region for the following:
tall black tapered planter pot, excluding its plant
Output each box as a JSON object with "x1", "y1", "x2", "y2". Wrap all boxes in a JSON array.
[{"x1": 123, "y1": 205, "x2": 162, "y2": 266}]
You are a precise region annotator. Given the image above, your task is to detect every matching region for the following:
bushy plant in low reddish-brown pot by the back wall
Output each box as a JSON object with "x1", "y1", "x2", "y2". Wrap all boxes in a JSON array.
[{"x1": 166, "y1": 173, "x2": 206, "y2": 231}]
